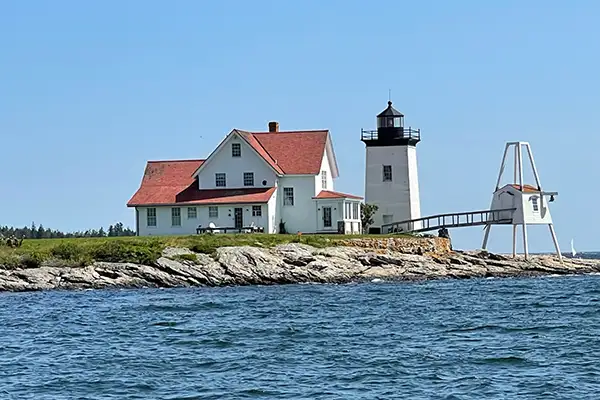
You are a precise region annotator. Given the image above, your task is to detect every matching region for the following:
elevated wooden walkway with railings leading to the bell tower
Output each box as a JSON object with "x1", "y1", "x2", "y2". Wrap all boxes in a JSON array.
[{"x1": 381, "y1": 208, "x2": 516, "y2": 233}]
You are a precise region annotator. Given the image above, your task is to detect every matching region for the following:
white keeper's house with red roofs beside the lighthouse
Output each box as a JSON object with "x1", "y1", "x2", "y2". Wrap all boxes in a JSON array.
[{"x1": 127, "y1": 122, "x2": 362, "y2": 236}]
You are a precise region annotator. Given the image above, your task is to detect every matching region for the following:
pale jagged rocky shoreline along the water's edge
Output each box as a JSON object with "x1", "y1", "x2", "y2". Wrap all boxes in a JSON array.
[{"x1": 0, "y1": 243, "x2": 600, "y2": 292}]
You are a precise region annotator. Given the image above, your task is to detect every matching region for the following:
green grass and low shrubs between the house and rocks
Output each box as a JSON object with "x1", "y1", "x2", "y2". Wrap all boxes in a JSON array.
[{"x1": 0, "y1": 234, "x2": 412, "y2": 268}]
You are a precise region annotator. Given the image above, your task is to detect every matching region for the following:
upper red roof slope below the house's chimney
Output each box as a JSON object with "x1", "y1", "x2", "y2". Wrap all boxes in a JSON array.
[{"x1": 238, "y1": 130, "x2": 329, "y2": 175}]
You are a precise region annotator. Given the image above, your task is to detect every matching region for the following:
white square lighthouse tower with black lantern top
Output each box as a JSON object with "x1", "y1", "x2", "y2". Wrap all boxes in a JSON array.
[{"x1": 361, "y1": 101, "x2": 421, "y2": 233}]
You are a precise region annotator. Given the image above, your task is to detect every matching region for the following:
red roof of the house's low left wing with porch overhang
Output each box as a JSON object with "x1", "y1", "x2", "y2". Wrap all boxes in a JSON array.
[{"x1": 127, "y1": 160, "x2": 275, "y2": 207}]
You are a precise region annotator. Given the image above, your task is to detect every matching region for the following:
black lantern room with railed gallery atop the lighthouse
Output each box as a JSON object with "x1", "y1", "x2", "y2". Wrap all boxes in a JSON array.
[{"x1": 361, "y1": 101, "x2": 421, "y2": 146}]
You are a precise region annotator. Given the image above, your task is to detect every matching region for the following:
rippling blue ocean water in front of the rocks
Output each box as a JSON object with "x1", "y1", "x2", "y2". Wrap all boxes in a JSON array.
[{"x1": 0, "y1": 275, "x2": 600, "y2": 400}]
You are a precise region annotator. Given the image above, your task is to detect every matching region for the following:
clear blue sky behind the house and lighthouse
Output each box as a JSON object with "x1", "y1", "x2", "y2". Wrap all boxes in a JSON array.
[{"x1": 0, "y1": 0, "x2": 600, "y2": 251}]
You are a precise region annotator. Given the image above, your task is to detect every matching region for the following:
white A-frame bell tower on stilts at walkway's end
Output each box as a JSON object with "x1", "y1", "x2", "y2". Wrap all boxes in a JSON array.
[{"x1": 482, "y1": 142, "x2": 562, "y2": 261}]
